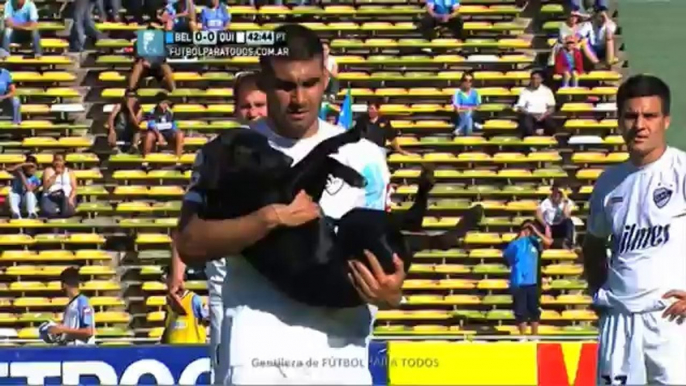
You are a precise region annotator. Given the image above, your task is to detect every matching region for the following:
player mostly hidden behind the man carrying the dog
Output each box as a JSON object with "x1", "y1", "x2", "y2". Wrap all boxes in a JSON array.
[{"x1": 168, "y1": 71, "x2": 267, "y2": 384}]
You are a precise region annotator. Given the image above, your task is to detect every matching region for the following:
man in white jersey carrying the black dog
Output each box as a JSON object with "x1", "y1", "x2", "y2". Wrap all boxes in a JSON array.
[{"x1": 175, "y1": 25, "x2": 405, "y2": 385}]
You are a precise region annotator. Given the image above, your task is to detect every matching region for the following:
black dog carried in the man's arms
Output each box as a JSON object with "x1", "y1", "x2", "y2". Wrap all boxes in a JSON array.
[{"x1": 197, "y1": 129, "x2": 480, "y2": 308}]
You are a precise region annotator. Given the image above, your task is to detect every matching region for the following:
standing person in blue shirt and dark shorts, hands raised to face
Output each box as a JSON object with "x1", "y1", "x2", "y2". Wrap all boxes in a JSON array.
[{"x1": 503, "y1": 220, "x2": 553, "y2": 335}]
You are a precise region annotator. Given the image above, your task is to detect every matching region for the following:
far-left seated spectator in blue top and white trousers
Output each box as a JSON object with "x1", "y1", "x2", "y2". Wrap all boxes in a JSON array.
[{"x1": 7, "y1": 155, "x2": 41, "y2": 219}]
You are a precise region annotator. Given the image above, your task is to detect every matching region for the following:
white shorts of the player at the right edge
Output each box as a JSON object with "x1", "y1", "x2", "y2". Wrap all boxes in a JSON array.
[{"x1": 597, "y1": 310, "x2": 686, "y2": 385}]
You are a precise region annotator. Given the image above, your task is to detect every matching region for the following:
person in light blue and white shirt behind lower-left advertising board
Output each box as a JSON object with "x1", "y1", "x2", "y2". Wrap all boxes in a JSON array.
[{"x1": 48, "y1": 267, "x2": 95, "y2": 345}]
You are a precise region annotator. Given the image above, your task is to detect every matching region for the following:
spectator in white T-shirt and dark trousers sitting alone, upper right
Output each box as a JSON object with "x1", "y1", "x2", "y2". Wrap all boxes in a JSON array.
[{"x1": 514, "y1": 71, "x2": 556, "y2": 137}]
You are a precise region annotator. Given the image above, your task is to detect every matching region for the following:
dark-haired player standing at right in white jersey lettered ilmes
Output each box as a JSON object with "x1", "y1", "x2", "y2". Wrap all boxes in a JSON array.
[{"x1": 583, "y1": 75, "x2": 686, "y2": 385}]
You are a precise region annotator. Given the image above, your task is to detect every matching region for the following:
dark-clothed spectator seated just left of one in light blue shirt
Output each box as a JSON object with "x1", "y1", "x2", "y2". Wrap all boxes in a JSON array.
[{"x1": 107, "y1": 92, "x2": 143, "y2": 153}]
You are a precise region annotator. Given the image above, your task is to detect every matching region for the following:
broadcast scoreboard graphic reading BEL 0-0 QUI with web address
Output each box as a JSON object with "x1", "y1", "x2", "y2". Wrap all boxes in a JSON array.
[{"x1": 136, "y1": 30, "x2": 288, "y2": 59}]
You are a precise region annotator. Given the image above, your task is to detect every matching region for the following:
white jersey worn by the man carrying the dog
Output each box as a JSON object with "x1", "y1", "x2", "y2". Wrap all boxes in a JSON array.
[{"x1": 188, "y1": 120, "x2": 390, "y2": 384}]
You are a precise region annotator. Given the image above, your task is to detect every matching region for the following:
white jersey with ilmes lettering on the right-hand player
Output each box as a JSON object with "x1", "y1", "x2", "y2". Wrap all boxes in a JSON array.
[{"x1": 588, "y1": 147, "x2": 686, "y2": 312}]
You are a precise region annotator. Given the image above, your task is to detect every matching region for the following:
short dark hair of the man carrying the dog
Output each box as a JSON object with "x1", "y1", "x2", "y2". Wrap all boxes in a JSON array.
[{"x1": 260, "y1": 24, "x2": 324, "y2": 74}]
